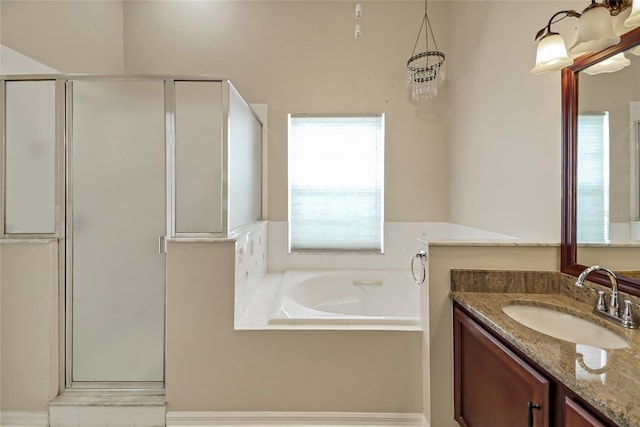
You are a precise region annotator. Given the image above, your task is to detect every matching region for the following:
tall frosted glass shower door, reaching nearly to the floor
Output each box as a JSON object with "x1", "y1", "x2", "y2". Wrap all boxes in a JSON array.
[{"x1": 67, "y1": 80, "x2": 166, "y2": 386}]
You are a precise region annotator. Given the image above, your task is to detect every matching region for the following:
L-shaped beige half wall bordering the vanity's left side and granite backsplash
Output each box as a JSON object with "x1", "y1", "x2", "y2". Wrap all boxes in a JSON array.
[{"x1": 424, "y1": 246, "x2": 560, "y2": 427}]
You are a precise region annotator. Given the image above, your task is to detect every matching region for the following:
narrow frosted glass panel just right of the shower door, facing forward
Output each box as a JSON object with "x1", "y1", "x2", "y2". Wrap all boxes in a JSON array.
[{"x1": 175, "y1": 81, "x2": 223, "y2": 233}]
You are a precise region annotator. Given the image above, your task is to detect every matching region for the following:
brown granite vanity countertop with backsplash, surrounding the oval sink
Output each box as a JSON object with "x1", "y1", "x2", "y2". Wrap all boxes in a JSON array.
[{"x1": 451, "y1": 270, "x2": 640, "y2": 427}]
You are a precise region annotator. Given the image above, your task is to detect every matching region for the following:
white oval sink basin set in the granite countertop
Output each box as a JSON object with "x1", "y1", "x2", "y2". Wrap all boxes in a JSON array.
[{"x1": 502, "y1": 304, "x2": 629, "y2": 349}]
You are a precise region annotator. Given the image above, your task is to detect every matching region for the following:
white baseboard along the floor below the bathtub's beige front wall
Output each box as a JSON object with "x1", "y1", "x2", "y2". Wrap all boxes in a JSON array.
[{"x1": 167, "y1": 411, "x2": 429, "y2": 427}]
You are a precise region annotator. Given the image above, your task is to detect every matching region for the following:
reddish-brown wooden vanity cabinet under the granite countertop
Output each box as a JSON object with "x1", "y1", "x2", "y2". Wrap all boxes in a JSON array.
[{"x1": 453, "y1": 304, "x2": 615, "y2": 427}]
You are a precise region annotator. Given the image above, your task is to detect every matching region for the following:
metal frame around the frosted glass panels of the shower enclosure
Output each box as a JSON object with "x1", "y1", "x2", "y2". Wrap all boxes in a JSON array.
[{"x1": 0, "y1": 74, "x2": 258, "y2": 394}]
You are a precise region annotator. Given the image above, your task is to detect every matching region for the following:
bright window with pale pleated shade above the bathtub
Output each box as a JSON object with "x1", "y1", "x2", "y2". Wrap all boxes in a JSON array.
[{"x1": 289, "y1": 114, "x2": 384, "y2": 252}]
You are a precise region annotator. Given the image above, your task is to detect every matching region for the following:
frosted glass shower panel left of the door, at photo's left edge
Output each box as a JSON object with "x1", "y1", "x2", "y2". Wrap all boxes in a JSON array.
[{"x1": 4, "y1": 80, "x2": 56, "y2": 234}]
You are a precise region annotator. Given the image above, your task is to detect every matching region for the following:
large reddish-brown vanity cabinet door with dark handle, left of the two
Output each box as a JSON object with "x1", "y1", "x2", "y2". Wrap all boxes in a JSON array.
[{"x1": 454, "y1": 307, "x2": 550, "y2": 427}]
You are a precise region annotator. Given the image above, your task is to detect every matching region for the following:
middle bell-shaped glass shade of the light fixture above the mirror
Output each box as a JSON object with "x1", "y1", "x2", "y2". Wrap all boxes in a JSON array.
[{"x1": 569, "y1": 5, "x2": 620, "y2": 55}]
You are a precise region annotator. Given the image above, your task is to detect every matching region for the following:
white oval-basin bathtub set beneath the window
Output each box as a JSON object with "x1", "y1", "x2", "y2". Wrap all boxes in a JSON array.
[{"x1": 269, "y1": 270, "x2": 420, "y2": 330}]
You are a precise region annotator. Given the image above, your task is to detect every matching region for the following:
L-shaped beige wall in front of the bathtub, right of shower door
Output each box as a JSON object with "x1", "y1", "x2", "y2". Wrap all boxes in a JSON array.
[{"x1": 166, "y1": 243, "x2": 422, "y2": 412}]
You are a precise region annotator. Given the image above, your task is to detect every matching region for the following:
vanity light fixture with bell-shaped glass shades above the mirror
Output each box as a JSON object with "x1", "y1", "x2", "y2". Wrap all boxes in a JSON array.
[{"x1": 531, "y1": 0, "x2": 640, "y2": 74}]
